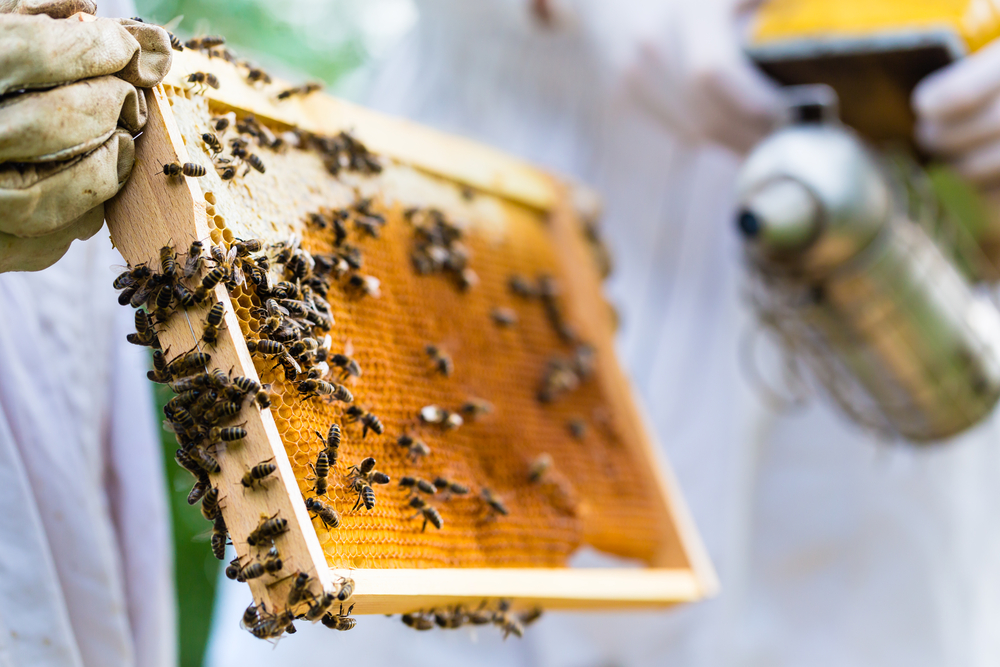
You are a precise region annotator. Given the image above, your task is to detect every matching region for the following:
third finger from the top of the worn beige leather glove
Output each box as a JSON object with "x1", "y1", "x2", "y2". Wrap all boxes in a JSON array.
[{"x1": 0, "y1": 130, "x2": 135, "y2": 237}]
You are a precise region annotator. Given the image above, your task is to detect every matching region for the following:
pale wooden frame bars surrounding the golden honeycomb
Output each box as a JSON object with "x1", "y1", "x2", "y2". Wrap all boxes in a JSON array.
[{"x1": 107, "y1": 51, "x2": 716, "y2": 614}]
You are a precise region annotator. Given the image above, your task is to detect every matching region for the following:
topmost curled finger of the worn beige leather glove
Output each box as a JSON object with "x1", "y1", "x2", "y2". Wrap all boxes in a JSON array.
[{"x1": 0, "y1": 14, "x2": 171, "y2": 95}]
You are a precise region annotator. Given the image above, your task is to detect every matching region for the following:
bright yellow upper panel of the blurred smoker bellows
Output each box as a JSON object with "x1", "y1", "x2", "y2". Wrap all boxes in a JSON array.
[{"x1": 751, "y1": 0, "x2": 1000, "y2": 52}]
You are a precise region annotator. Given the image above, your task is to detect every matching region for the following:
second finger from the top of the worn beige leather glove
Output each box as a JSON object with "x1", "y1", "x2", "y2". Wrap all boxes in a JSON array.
[{"x1": 0, "y1": 76, "x2": 146, "y2": 162}]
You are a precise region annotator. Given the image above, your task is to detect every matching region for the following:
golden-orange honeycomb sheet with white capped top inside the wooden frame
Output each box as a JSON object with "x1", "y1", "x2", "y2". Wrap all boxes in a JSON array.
[{"x1": 166, "y1": 87, "x2": 662, "y2": 568}]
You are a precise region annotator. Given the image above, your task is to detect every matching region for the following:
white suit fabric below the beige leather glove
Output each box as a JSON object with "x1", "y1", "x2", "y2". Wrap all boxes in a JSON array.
[{"x1": 0, "y1": 0, "x2": 176, "y2": 667}]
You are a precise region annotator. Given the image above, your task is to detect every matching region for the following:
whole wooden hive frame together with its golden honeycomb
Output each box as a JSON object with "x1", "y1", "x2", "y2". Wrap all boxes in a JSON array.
[{"x1": 107, "y1": 51, "x2": 713, "y2": 614}]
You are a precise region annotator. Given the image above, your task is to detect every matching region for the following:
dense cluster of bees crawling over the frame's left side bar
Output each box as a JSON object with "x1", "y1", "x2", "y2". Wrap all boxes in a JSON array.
[{"x1": 114, "y1": 239, "x2": 368, "y2": 638}]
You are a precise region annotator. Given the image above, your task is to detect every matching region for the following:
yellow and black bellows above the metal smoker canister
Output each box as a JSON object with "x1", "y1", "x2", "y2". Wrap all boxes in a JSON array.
[{"x1": 748, "y1": 0, "x2": 1000, "y2": 145}]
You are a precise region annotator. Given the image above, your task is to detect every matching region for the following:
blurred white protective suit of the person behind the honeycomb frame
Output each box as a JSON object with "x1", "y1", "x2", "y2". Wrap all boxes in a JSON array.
[{"x1": 207, "y1": 0, "x2": 1000, "y2": 667}]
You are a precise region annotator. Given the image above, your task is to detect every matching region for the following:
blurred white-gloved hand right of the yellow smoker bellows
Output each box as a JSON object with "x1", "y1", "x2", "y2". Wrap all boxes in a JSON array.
[{"x1": 911, "y1": 40, "x2": 1000, "y2": 194}]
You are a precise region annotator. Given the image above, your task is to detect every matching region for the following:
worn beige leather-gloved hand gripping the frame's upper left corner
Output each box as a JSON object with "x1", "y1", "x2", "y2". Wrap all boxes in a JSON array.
[{"x1": 0, "y1": 0, "x2": 172, "y2": 272}]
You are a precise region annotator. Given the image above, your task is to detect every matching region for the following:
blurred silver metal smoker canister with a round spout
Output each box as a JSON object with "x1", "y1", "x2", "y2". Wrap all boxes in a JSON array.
[{"x1": 737, "y1": 122, "x2": 1000, "y2": 441}]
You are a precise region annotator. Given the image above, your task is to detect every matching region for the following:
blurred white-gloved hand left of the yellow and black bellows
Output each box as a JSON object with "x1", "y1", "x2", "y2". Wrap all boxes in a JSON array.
[{"x1": 628, "y1": 0, "x2": 784, "y2": 154}]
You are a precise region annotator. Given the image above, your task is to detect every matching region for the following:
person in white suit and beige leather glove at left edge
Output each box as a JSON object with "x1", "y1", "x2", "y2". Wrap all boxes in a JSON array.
[{"x1": 0, "y1": 0, "x2": 176, "y2": 667}]
